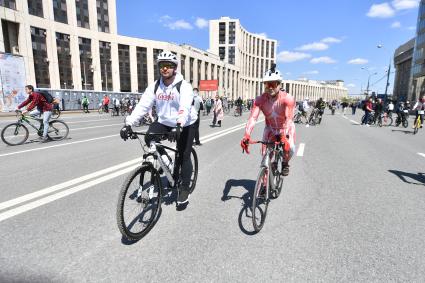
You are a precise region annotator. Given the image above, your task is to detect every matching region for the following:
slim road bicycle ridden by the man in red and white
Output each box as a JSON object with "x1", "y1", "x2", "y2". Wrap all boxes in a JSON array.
[{"x1": 242, "y1": 137, "x2": 289, "y2": 232}]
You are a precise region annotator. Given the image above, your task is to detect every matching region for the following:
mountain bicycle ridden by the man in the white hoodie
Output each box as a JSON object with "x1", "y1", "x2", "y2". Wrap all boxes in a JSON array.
[{"x1": 116, "y1": 132, "x2": 198, "y2": 241}]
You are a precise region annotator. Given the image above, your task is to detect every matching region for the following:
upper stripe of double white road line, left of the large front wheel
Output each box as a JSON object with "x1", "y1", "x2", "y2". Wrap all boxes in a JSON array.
[{"x1": 0, "y1": 157, "x2": 143, "y2": 210}]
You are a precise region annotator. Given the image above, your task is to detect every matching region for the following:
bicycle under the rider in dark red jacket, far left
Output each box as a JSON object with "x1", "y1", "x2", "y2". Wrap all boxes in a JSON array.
[{"x1": 1, "y1": 111, "x2": 69, "y2": 146}]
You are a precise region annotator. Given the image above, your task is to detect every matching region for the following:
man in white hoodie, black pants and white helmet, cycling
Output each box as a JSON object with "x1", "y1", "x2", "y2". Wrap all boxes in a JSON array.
[{"x1": 120, "y1": 51, "x2": 198, "y2": 206}]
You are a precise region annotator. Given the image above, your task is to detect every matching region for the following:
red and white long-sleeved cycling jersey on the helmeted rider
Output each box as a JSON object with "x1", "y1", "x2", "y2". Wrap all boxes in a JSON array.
[{"x1": 245, "y1": 91, "x2": 295, "y2": 160}]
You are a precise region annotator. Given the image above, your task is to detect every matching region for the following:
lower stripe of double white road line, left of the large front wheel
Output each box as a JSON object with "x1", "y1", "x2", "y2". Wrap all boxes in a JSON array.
[{"x1": 0, "y1": 164, "x2": 139, "y2": 222}]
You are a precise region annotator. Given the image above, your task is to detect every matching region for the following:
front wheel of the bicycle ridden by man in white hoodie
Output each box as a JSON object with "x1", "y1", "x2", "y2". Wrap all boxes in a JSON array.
[{"x1": 116, "y1": 165, "x2": 161, "y2": 241}]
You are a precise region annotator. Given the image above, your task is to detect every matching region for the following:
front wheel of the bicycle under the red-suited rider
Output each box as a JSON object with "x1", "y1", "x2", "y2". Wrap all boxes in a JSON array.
[{"x1": 252, "y1": 167, "x2": 269, "y2": 232}]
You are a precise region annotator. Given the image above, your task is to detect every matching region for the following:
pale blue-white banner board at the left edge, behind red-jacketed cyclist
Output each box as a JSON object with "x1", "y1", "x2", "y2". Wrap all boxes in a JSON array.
[{"x1": 0, "y1": 53, "x2": 28, "y2": 112}]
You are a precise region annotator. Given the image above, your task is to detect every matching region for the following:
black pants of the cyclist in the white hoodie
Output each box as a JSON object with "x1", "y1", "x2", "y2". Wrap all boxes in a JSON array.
[{"x1": 145, "y1": 122, "x2": 195, "y2": 188}]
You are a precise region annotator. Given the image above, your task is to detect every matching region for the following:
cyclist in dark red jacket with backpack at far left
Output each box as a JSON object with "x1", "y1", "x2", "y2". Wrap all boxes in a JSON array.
[{"x1": 17, "y1": 85, "x2": 53, "y2": 143}]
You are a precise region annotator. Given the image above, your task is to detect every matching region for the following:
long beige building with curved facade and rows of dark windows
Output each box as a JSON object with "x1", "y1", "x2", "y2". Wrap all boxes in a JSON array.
[{"x1": 0, "y1": 0, "x2": 344, "y2": 99}]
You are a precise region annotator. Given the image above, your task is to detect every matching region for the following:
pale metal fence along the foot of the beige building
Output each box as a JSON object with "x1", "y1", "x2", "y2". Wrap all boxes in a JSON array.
[{"x1": 36, "y1": 88, "x2": 142, "y2": 110}]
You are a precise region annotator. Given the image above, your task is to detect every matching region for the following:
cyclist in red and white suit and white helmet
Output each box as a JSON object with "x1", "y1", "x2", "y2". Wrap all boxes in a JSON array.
[{"x1": 241, "y1": 64, "x2": 295, "y2": 176}]
